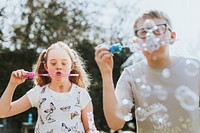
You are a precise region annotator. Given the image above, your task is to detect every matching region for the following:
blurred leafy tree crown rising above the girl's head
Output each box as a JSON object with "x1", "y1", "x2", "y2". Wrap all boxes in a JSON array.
[{"x1": 11, "y1": 0, "x2": 90, "y2": 49}]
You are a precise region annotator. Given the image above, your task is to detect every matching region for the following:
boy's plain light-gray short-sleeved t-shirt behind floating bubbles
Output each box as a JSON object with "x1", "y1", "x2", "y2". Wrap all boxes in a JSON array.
[{"x1": 115, "y1": 56, "x2": 200, "y2": 133}]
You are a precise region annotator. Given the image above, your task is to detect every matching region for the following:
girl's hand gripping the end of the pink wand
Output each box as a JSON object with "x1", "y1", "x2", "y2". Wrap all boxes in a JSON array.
[{"x1": 9, "y1": 69, "x2": 28, "y2": 86}]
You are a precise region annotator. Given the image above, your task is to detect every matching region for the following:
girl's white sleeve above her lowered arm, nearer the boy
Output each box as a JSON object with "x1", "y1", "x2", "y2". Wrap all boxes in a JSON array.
[{"x1": 80, "y1": 88, "x2": 91, "y2": 110}]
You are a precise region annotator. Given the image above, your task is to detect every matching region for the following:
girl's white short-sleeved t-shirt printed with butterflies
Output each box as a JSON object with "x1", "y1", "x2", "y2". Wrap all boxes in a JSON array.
[{"x1": 27, "y1": 84, "x2": 91, "y2": 133}]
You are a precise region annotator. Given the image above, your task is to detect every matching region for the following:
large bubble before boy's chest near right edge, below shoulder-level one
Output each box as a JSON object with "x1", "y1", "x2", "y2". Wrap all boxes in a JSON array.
[{"x1": 175, "y1": 86, "x2": 199, "y2": 111}]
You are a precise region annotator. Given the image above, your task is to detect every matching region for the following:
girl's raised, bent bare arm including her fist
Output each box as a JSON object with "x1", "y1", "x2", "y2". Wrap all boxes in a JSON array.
[{"x1": 0, "y1": 70, "x2": 31, "y2": 118}]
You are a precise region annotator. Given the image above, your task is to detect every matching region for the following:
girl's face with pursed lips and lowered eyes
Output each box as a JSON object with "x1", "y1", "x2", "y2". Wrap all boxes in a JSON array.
[{"x1": 45, "y1": 48, "x2": 72, "y2": 79}]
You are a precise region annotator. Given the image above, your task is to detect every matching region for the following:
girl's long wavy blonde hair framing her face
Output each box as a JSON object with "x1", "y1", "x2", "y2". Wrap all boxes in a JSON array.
[{"x1": 34, "y1": 42, "x2": 90, "y2": 88}]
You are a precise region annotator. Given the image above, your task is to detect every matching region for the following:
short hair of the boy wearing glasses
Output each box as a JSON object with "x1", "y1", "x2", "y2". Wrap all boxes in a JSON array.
[{"x1": 133, "y1": 10, "x2": 172, "y2": 33}]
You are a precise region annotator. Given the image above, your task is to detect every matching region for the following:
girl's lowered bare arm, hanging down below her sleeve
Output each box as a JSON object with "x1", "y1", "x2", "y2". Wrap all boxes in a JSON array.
[{"x1": 82, "y1": 101, "x2": 100, "y2": 133}]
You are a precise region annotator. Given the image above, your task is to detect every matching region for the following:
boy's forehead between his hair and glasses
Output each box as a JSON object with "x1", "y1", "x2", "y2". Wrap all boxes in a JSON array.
[{"x1": 135, "y1": 18, "x2": 166, "y2": 30}]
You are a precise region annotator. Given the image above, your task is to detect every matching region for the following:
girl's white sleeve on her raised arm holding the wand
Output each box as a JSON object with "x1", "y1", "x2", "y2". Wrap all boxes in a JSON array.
[{"x1": 26, "y1": 86, "x2": 41, "y2": 108}]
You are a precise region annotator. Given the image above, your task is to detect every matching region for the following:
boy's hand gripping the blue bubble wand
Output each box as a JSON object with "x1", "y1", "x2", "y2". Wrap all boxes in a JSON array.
[{"x1": 95, "y1": 44, "x2": 114, "y2": 74}]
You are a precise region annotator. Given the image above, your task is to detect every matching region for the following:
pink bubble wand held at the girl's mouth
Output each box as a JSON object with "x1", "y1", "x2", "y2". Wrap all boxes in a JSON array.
[{"x1": 26, "y1": 72, "x2": 79, "y2": 78}]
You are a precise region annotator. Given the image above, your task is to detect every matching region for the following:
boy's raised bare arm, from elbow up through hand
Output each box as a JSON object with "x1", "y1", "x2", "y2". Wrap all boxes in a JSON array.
[{"x1": 95, "y1": 45, "x2": 125, "y2": 130}]
